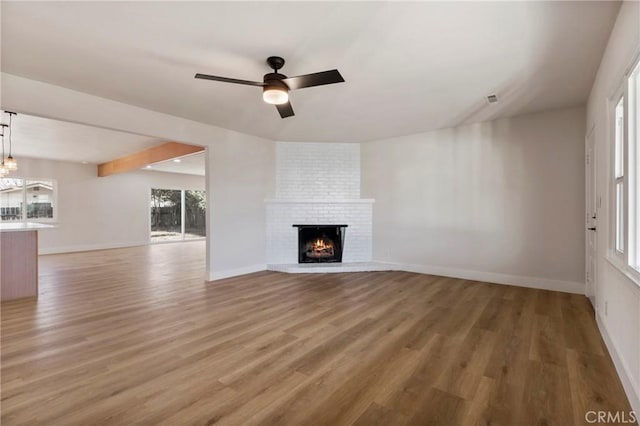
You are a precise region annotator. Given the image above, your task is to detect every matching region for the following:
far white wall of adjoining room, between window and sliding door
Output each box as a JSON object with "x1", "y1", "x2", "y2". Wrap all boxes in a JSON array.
[{"x1": 16, "y1": 157, "x2": 205, "y2": 253}]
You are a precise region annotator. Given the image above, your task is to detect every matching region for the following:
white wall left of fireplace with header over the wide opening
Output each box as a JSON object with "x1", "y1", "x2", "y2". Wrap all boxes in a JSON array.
[{"x1": 0, "y1": 73, "x2": 275, "y2": 279}]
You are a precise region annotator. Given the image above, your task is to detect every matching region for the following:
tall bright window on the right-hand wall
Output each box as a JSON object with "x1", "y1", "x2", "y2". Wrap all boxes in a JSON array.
[{"x1": 611, "y1": 55, "x2": 640, "y2": 277}]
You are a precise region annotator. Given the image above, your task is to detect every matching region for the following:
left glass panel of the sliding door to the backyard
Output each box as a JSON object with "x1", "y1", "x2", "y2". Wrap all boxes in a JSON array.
[{"x1": 151, "y1": 189, "x2": 182, "y2": 241}]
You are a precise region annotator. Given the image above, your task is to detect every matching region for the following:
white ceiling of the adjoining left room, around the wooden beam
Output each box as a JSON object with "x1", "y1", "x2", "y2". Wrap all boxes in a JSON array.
[{"x1": 0, "y1": 112, "x2": 204, "y2": 176}]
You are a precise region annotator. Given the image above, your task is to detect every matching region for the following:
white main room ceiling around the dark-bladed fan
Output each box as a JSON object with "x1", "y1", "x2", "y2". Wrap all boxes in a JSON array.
[{"x1": 2, "y1": 1, "x2": 620, "y2": 141}]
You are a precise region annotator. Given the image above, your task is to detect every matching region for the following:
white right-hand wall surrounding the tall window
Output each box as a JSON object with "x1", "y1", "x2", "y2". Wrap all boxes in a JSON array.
[{"x1": 586, "y1": 1, "x2": 640, "y2": 413}]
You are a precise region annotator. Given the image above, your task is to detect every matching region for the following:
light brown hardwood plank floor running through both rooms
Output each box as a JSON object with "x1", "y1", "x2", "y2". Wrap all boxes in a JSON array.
[{"x1": 1, "y1": 242, "x2": 630, "y2": 426}]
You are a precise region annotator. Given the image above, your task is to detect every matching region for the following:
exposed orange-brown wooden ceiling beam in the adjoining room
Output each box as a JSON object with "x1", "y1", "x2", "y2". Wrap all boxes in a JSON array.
[{"x1": 98, "y1": 142, "x2": 204, "y2": 177}]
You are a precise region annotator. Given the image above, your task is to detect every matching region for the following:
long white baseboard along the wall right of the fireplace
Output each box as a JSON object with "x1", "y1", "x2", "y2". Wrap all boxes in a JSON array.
[{"x1": 380, "y1": 262, "x2": 585, "y2": 295}]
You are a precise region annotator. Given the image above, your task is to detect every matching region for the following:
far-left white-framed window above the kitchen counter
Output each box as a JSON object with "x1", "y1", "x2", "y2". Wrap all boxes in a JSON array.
[{"x1": 0, "y1": 178, "x2": 56, "y2": 222}]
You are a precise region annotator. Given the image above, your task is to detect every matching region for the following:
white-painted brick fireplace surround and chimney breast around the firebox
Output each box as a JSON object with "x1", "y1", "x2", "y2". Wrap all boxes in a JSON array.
[{"x1": 266, "y1": 142, "x2": 374, "y2": 270}]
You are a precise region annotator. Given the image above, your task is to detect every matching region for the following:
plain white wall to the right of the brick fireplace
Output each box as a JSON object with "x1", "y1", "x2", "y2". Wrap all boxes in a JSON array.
[{"x1": 361, "y1": 108, "x2": 585, "y2": 292}]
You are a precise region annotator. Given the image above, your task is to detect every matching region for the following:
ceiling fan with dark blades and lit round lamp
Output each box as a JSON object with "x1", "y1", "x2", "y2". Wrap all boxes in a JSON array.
[{"x1": 195, "y1": 56, "x2": 344, "y2": 118}]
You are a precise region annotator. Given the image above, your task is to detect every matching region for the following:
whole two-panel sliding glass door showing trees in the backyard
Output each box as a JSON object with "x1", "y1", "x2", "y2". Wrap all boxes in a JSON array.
[{"x1": 151, "y1": 188, "x2": 207, "y2": 242}]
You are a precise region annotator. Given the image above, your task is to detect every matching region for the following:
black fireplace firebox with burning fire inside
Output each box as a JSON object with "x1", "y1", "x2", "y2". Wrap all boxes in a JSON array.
[{"x1": 293, "y1": 225, "x2": 348, "y2": 263}]
